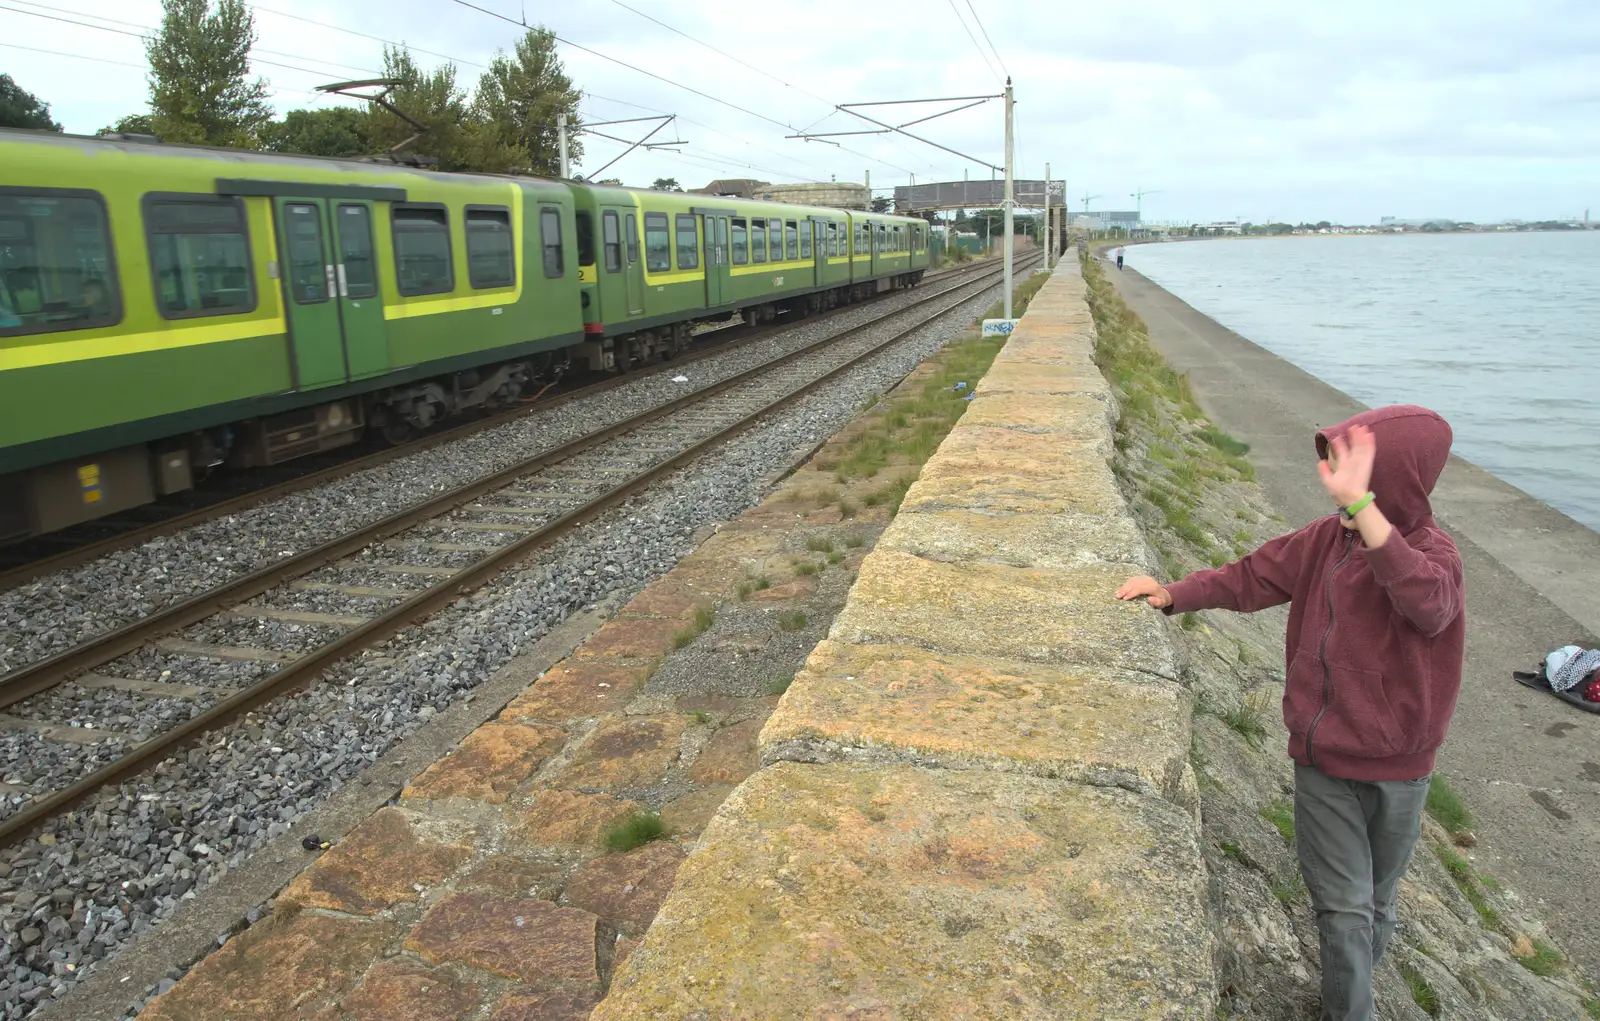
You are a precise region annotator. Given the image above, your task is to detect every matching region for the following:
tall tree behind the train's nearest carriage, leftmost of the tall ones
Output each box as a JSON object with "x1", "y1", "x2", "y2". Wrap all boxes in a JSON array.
[{"x1": 144, "y1": 0, "x2": 272, "y2": 147}]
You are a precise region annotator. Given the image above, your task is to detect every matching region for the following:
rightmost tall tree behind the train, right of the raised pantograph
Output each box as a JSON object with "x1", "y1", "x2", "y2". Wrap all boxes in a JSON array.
[{"x1": 464, "y1": 29, "x2": 584, "y2": 178}]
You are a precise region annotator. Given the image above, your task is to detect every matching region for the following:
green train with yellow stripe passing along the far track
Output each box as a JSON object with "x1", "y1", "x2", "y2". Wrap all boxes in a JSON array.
[{"x1": 0, "y1": 130, "x2": 928, "y2": 541}]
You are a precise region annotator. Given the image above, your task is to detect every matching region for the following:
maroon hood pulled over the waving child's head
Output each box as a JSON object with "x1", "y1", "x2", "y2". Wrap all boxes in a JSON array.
[{"x1": 1317, "y1": 405, "x2": 1453, "y2": 533}]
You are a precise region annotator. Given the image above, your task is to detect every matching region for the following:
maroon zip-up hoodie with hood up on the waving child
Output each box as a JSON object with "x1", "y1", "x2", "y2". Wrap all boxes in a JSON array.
[{"x1": 1166, "y1": 405, "x2": 1466, "y2": 781}]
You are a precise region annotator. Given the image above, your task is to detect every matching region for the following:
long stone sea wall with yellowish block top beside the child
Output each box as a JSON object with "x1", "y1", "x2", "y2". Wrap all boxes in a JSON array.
[{"x1": 594, "y1": 262, "x2": 1218, "y2": 1021}]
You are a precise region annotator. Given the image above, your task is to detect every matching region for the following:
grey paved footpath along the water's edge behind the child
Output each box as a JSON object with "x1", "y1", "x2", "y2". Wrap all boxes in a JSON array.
[{"x1": 1107, "y1": 266, "x2": 1600, "y2": 978}]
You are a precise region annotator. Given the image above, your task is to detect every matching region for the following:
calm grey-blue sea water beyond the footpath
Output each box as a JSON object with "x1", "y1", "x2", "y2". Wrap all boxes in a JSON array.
[{"x1": 1112, "y1": 230, "x2": 1600, "y2": 530}]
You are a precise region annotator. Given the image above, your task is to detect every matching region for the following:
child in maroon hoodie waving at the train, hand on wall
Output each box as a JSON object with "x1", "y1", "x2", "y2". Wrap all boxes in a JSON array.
[{"x1": 1117, "y1": 405, "x2": 1466, "y2": 1021}]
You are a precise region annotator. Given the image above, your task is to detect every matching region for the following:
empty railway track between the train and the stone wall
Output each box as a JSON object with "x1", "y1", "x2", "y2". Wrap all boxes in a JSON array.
[{"x1": 0, "y1": 259, "x2": 1037, "y2": 847}]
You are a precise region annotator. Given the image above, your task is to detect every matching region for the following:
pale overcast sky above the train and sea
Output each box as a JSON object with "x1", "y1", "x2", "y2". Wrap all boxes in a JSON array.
[{"x1": 0, "y1": 0, "x2": 1600, "y2": 222}]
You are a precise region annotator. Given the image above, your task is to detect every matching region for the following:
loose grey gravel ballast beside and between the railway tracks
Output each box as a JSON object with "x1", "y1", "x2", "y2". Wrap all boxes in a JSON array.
[{"x1": 0, "y1": 275, "x2": 1017, "y2": 1019}]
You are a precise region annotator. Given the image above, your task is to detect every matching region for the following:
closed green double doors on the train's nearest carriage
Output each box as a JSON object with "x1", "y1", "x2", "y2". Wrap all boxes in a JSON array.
[{"x1": 274, "y1": 197, "x2": 389, "y2": 390}]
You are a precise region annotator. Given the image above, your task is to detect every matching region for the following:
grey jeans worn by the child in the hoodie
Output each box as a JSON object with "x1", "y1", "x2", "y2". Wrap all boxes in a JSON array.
[{"x1": 1294, "y1": 765, "x2": 1430, "y2": 1021}]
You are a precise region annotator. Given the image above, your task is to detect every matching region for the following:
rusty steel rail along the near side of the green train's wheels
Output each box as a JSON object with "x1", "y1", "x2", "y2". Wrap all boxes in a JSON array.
[{"x1": 0, "y1": 256, "x2": 984, "y2": 592}]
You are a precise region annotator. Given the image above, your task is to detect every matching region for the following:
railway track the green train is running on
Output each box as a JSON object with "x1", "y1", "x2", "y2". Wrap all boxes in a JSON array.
[{"x1": 0, "y1": 256, "x2": 992, "y2": 592}]
